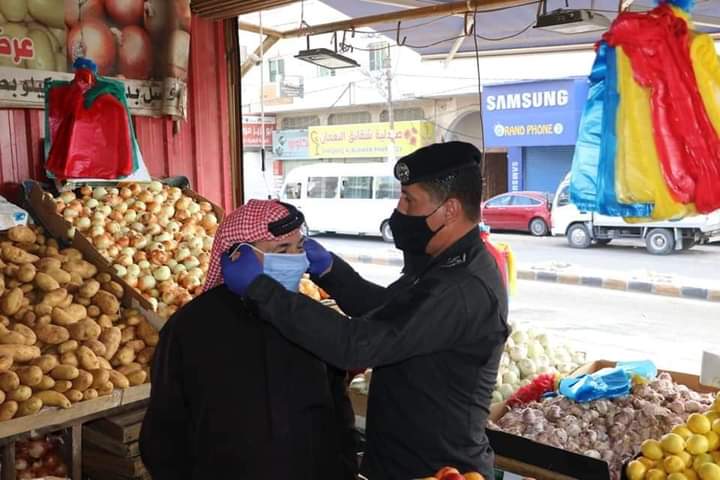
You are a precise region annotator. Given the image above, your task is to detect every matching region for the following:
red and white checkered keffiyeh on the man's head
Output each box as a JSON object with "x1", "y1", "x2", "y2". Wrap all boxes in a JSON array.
[{"x1": 203, "y1": 200, "x2": 293, "y2": 292}]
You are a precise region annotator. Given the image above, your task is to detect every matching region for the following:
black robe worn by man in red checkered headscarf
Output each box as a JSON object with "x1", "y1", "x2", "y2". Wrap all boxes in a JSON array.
[{"x1": 140, "y1": 286, "x2": 357, "y2": 480}]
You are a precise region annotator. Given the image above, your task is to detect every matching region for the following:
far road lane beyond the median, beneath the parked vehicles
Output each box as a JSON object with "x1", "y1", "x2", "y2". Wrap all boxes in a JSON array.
[{"x1": 317, "y1": 233, "x2": 720, "y2": 285}]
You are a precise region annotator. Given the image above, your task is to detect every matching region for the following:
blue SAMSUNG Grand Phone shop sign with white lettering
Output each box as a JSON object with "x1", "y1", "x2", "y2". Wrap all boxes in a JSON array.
[{"x1": 483, "y1": 79, "x2": 588, "y2": 147}]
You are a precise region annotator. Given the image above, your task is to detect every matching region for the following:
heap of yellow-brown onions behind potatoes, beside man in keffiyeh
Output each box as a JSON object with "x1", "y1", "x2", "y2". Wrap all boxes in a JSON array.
[{"x1": 56, "y1": 182, "x2": 219, "y2": 318}]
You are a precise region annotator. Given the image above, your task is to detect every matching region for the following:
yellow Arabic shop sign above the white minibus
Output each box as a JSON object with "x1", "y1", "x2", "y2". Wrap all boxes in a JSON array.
[{"x1": 308, "y1": 121, "x2": 435, "y2": 158}]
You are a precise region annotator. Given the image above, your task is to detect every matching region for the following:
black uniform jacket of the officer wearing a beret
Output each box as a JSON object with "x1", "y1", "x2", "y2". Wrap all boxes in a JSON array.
[{"x1": 247, "y1": 229, "x2": 508, "y2": 480}]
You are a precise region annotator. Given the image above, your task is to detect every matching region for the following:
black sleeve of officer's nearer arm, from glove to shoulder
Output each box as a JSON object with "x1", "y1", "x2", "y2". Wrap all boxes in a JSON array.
[{"x1": 246, "y1": 275, "x2": 492, "y2": 369}]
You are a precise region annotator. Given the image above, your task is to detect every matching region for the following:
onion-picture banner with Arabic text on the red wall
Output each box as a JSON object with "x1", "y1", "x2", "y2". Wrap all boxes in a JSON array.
[{"x1": 0, "y1": 0, "x2": 191, "y2": 118}]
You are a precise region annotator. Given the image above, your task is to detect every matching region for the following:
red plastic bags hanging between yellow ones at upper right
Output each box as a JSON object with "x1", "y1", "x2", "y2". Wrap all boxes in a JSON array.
[{"x1": 603, "y1": 4, "x2": 720, "y2": 213}]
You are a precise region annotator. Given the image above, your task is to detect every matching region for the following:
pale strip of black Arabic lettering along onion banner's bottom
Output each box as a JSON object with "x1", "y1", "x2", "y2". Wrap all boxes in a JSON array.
[{"x1": 0, "y1": 67, "x2": 187, "y2": 118}]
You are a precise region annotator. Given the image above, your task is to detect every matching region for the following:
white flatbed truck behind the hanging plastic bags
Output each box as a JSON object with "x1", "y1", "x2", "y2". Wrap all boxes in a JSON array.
[{"x1": 552, "y1": 174, "x2": 720, "y2": 255}]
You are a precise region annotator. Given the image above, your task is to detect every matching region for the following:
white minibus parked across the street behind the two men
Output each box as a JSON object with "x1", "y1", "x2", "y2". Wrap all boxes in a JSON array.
[{"x1": 280, "y1": 163, "x2": 400, "y2": 242}]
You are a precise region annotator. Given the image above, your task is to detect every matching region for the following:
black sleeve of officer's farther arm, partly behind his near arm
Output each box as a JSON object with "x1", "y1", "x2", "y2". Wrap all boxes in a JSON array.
[{"x1": 313, "y1": 254, "x2": 387, "y2": 317}]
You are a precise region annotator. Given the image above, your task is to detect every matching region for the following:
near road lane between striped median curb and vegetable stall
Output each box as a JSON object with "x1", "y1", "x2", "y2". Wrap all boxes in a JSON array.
[{"x1": 346, "y1": 264, "x2": 720, "y2": 374}]
